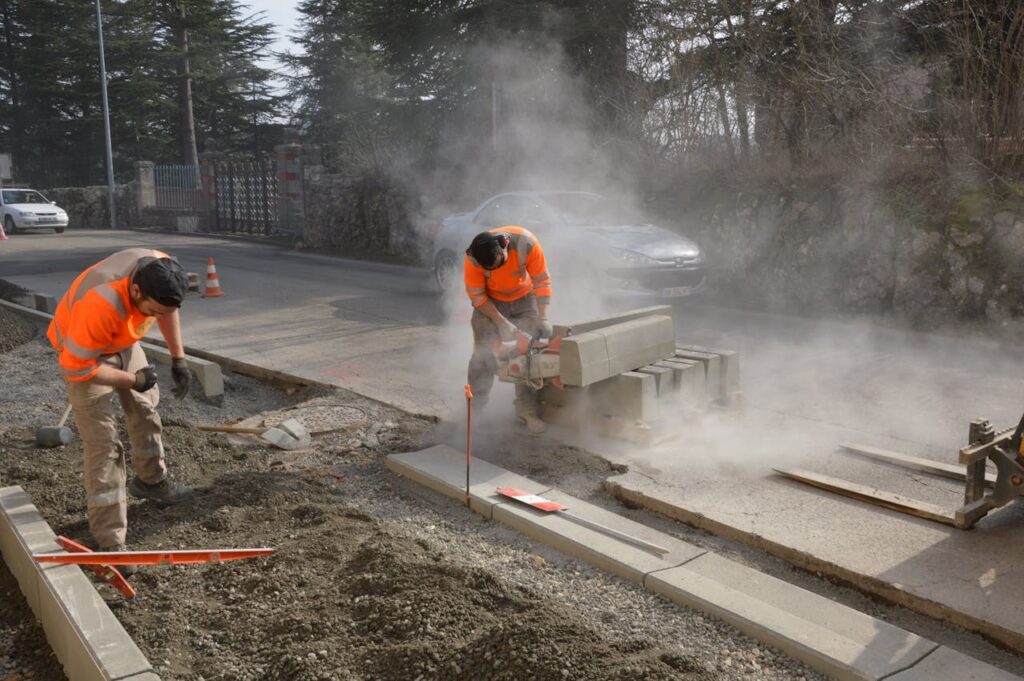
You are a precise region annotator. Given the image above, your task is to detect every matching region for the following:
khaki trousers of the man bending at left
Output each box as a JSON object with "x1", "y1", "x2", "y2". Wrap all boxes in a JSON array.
[{"x1": 67, "y1": 343, "x2": 167, "y2": 549}]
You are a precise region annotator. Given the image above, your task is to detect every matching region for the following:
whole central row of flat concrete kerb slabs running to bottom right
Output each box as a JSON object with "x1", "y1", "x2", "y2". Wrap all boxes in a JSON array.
[{"x1": 388, "y1": 445, "x2": 1015, "y2": 681}]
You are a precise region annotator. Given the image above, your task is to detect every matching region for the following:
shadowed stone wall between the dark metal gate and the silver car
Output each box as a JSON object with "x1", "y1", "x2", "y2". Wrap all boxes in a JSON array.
[{"x1": 302, "y1": 167, "x2": 429, "y2": 263}]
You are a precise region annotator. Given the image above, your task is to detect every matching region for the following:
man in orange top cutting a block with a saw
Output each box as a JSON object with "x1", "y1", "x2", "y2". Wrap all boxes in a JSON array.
[{"x1": 463, "y1": 225, "x2": 552, "y2": 433}]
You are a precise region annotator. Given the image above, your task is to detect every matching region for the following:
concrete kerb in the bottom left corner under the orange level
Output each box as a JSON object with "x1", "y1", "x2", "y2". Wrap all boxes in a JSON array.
[{"x1": 0, "y1": 486, "x2": 160, "y2": 681}]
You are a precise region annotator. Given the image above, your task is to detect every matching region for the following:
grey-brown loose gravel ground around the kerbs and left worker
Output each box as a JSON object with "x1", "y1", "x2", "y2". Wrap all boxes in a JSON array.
[{"x1": 0, "y1": 309, "x2": 1015, "y2": 681}]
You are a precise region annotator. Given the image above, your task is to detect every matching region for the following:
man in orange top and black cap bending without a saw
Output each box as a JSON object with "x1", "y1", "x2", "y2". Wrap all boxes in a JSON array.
[{"x1": 47, "y1": 248, "x2": 191, "y2": 551}]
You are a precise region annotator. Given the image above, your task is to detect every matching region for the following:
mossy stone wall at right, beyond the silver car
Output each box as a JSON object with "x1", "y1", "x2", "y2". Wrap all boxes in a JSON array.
[{"x1": 692, "y1": 180, "x2": 1024, "y2": 325}]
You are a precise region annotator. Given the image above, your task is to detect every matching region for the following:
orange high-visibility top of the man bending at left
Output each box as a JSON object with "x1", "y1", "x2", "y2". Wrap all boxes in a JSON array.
[{"x1": 46, "y1": 248, "x2": 170, "y2": 381}]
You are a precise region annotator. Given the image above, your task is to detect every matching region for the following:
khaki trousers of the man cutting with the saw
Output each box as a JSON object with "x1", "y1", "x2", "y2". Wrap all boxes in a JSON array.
[{"x1": 468, "y1": 293, "x2": 540, "y2": 416}]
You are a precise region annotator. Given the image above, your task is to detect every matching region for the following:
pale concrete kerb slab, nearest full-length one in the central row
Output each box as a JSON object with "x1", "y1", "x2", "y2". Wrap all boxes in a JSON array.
[{"x1": 646, "y1": 553, "x2": 937, "y2": 681}]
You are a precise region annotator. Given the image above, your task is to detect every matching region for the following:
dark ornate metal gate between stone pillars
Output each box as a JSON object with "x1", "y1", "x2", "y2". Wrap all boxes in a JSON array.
[{"x1": 214, "y1": 159, "x2": 278, "y2": 235}]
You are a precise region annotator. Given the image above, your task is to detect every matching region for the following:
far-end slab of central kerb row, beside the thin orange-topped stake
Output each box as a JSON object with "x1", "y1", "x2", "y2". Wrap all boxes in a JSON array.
[{"x1": 387, "y1": 444, "x2": 548, "y2": 518}]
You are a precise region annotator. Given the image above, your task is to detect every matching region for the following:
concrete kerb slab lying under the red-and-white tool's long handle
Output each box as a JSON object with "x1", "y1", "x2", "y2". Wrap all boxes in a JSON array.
[{"x1": 494, "y1": 490, "x2": 706, "y2": 585}]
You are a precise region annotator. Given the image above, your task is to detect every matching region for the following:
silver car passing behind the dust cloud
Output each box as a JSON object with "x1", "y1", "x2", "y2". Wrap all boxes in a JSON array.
[{"x1": 433, "y1": 191, "x2": 705, "y2": 298}]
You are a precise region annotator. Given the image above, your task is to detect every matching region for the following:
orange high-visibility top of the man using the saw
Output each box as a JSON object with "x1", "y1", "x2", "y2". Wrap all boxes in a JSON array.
[{"x1": 463, "y1": 225, "x2": 551, "y2": 307}]
